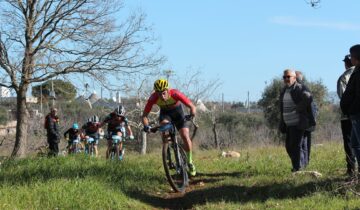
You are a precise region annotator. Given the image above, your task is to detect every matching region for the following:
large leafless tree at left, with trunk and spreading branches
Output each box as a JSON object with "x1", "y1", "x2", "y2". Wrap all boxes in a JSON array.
[{"x1": 0, "y1": 0, "x2": 163, "y2": 157}]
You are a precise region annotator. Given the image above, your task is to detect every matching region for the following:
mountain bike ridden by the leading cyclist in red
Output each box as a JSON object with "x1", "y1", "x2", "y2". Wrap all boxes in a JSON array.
[{"x1": 150, "y1": 116, "x2": 198, "y2": 192}]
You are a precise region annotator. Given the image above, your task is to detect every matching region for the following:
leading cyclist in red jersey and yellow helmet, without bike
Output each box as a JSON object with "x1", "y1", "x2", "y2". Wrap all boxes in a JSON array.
[{"x1": 142, "y1": 79, "x2": 196, "y2": 176}]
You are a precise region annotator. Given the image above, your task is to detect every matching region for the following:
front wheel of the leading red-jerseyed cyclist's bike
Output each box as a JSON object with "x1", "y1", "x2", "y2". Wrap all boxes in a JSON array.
[{"x1": 162, "y1": 139, "x2": 188, "y2": 192}]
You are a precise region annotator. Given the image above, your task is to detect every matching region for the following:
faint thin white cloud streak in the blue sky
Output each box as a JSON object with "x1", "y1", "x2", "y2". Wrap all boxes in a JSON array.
[{"x1": 269, "y1": 16, "x2": 360, "y2": 31}]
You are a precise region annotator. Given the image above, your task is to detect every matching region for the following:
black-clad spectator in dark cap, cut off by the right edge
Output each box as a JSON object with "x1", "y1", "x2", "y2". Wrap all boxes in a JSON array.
[{"x1": 340, "y1": 44, "x2": 360, "y2": 176}]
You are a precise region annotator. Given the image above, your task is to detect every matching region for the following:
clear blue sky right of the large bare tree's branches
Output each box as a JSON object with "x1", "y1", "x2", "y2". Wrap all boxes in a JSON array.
[{"x1": 124, "y1": 0, "x2": 360, "y2": 101}]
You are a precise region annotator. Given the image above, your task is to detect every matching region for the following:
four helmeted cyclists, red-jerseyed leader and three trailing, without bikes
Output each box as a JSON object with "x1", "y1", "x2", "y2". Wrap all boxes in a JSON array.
[{"x1": 64, "y1": 79, "x2": 196, "y2": 176}]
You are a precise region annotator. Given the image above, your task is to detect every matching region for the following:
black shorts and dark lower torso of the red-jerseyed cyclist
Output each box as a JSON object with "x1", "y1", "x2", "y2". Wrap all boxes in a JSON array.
[{"x1": 159, "y1": 105, "x2": 189, "y2": 130}]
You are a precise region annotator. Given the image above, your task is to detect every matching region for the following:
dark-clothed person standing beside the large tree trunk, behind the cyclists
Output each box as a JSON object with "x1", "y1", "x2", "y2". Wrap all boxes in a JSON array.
[{"x1": 45, "y1": 108, "x2": 60, "y2": 156}]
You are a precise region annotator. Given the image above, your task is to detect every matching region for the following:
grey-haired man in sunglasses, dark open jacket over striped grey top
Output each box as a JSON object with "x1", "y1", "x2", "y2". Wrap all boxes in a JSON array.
[{"x1": 280, "y1": 69, "x2": 313, "y2": 172}]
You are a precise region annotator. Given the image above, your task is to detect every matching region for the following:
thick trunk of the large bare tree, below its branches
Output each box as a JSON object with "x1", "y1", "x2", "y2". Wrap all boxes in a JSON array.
[{"x1": 11, "y1": 86, "x2": 29, "y2": 157}]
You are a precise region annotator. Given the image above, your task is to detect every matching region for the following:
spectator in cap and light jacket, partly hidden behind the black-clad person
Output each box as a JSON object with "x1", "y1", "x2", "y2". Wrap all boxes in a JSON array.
[{"x1": 337, "y1": 55, "x2": 355, "y2": 176}]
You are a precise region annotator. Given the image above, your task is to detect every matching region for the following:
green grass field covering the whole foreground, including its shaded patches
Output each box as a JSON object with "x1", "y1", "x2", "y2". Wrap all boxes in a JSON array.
[{"x1": 0, "y1": 143, "x2": 360, "y2": 209}]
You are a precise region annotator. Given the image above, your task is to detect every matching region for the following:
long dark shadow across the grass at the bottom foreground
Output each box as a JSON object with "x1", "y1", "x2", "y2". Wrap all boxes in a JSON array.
[{"x1": 127, "y1": 179, "x2": 341, "y2": 209}]
